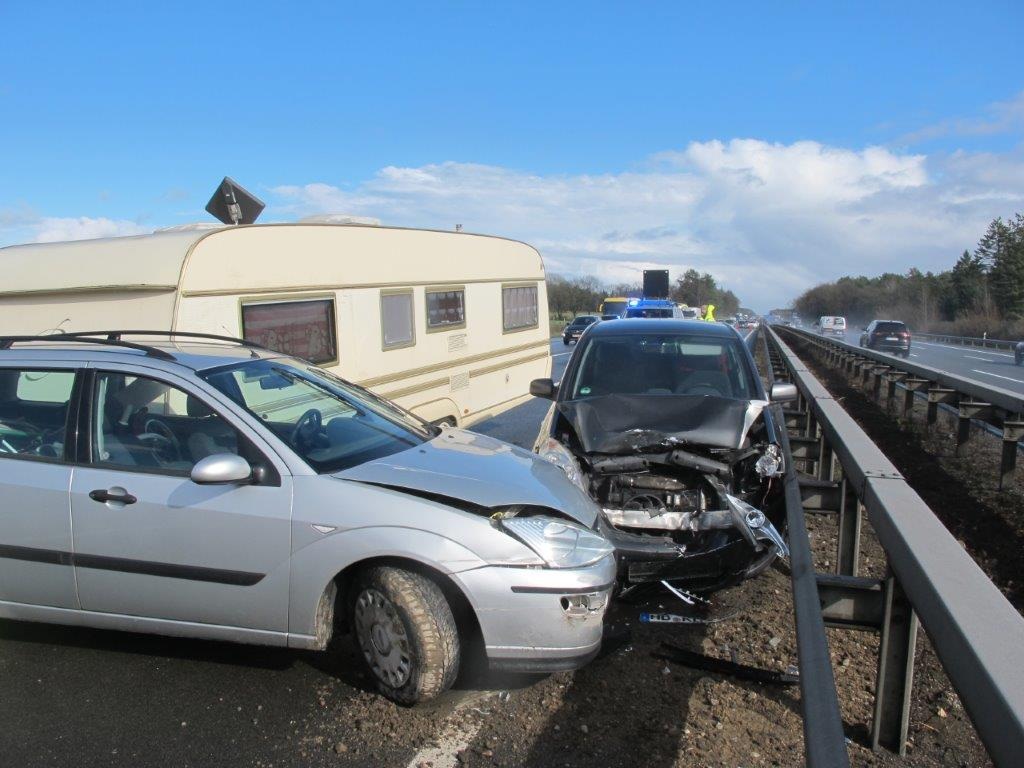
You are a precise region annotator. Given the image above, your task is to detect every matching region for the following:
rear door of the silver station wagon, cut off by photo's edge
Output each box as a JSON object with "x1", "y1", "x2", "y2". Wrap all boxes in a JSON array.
[{"x1": 0, "y1": 362, "x2": 79, "y2": 608}]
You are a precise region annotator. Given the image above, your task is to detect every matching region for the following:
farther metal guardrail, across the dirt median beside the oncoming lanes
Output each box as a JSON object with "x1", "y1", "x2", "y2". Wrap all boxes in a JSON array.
[{"x1": 777, "y1": 328, "x2": 1024, "y2": 488}]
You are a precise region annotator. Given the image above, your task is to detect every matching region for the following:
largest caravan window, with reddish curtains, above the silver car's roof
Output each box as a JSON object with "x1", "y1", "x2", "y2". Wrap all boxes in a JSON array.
[{"x1": 242, "y1": 298, "x2": 338, "y2": 364}]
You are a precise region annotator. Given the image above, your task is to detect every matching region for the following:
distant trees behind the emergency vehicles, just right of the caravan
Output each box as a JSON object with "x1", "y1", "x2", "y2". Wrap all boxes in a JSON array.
[{"x1": 548, "y1": 269, "x2": 739, "y2": 316}]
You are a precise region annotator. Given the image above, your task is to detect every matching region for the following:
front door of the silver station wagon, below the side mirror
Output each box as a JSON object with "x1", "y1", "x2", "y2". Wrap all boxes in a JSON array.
[{"x1": 71, "y1": 366, "x2": 292, "y2": 635}]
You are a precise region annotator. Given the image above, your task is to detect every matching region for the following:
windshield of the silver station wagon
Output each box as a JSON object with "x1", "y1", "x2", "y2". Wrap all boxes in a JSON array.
[{"x1": 200, "y1": 359, "x2": 431, "y2": 473}]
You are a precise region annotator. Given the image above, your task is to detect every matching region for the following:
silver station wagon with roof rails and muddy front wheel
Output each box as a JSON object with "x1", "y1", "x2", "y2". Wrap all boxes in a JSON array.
[{"x1": 0, "y1": 331, "x2": 615, "y2": 703}]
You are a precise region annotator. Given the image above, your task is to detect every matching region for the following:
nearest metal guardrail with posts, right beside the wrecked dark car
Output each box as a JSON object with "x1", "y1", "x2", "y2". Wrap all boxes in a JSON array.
[{"x1": 765, "y1": 329, "x2": 1024, "y2": 766}]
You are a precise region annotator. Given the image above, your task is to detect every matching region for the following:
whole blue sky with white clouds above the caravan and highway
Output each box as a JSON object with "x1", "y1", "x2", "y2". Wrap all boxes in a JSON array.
[{"x1": 0, "y1": 0, "x2": 1024, "y2": 305}]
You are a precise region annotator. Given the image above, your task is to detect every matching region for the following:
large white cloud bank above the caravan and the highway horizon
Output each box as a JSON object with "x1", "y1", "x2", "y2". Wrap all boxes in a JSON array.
[{"x1": 271, "y1": 139, "x2": 1024, "y2": 309}]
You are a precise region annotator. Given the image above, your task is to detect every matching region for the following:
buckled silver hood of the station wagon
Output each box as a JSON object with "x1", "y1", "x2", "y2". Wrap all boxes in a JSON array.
[{"x1": 334, "y1": 429, "x2": 598, "y2": 527}]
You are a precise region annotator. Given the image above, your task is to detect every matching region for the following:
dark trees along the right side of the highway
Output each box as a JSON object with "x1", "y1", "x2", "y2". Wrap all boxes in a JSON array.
[{"x1": 794, "y1": 213, "x2": 1024, "y2": 337}]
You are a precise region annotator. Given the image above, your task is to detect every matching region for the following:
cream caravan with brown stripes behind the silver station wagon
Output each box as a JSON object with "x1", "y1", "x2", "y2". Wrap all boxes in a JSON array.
[{"x1": 0, "y1": 223, "x2": 551, "y2": 426}]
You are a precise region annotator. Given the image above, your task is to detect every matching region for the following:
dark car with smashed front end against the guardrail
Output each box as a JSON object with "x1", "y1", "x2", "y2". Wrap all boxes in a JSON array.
[{"x1": 530, "y1": 319, "x2": 796, "y2": 591}]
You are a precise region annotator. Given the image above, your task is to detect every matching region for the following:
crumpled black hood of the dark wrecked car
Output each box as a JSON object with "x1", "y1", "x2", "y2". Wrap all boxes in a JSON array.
[{"x1": 557, "y1": 394, "x2": 766, "y2": 454}]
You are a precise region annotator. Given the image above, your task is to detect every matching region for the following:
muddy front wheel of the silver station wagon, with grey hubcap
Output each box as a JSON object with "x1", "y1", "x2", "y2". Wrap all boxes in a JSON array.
[{"x1": 349, "y1": 566, "x2": 461, "y2": 705}]
